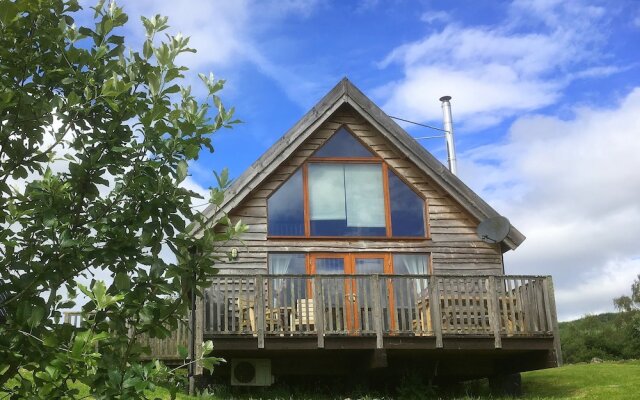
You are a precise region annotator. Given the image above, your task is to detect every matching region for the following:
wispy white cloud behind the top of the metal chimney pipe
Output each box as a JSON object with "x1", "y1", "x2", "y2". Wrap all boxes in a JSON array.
[{"x1": 377, "y1": 1, "x2": 618, "y2": 128}]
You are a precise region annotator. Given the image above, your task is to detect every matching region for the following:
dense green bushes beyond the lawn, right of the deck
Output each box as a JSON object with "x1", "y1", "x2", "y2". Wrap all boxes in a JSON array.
[{"x1": 560, "y1": 310, "x2": 640, "y2": 363}]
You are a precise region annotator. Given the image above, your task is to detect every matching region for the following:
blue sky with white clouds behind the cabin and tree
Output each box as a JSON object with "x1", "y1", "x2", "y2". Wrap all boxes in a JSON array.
[{"x1": 82, "y1": 0, "x2": 640, "y2": 319}]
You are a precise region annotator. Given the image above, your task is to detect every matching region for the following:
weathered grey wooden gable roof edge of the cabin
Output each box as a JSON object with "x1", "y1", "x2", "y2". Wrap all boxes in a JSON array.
[{"x1": 191, "y1": 78, "x2": 525, "y2": 250}]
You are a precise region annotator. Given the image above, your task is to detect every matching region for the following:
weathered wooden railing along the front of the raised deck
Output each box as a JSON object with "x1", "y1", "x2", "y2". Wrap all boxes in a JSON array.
[{"x1": 203, "y1": 275, "x2": 557, "y2": 347}]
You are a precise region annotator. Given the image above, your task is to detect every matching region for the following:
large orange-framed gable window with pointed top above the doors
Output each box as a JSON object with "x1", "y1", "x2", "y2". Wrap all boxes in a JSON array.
[{"x1": 267, "y1": 128, "x2": 426, "y2": 238}]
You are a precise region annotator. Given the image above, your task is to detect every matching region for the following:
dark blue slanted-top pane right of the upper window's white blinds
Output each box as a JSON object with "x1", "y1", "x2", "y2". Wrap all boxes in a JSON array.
[{"x1": 389, "y1": 170, "x2": 425, "y2": 237}]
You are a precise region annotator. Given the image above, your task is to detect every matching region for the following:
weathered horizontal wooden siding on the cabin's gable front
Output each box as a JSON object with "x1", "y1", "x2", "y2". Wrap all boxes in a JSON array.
[{"x1": 212, "y1": 105, "x2": 503, "y2": 274}]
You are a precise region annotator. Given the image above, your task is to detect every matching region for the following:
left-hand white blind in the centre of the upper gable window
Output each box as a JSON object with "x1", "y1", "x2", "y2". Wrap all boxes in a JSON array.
[{"x1": 309, "y1": 164, "x2": 346, "y2": 221}]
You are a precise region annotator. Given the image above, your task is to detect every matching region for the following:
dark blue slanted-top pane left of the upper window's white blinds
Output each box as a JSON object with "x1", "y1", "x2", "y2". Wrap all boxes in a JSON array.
[{"x1": 267, "y1": 170, "x2": 304, "y2": 236}]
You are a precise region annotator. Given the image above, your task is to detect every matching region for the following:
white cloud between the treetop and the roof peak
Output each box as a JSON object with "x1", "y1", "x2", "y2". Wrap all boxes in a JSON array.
[{"x1": 111, "y1": 0, "x2": 321, "y2": 103}]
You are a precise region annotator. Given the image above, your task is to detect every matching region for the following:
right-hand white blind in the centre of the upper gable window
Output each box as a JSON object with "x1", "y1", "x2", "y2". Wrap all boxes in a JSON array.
[{"x1": 344, "y1": 164, "x2": 385, "y2": 228}]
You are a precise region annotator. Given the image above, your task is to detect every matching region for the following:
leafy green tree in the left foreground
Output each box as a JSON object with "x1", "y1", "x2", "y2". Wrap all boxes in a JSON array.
[{"x1": 0, "y1": 0, "x2": 245, "y2": 399}]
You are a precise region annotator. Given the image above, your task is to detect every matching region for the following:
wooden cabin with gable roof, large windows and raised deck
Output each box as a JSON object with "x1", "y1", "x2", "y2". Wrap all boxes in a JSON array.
[{"x1": 190, "y1": 79, "x2": 561, "y2": 384}]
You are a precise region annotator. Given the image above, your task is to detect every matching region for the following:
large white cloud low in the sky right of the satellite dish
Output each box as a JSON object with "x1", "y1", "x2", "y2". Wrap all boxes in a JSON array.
[{"x1": 458, "y1": 88, "x2": 640, "y2": 319}]
